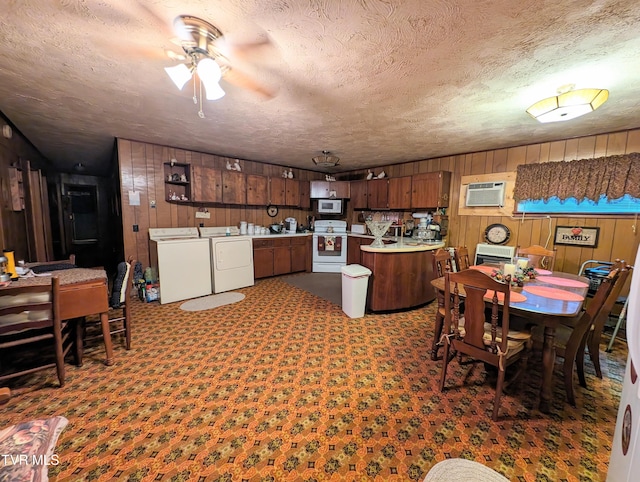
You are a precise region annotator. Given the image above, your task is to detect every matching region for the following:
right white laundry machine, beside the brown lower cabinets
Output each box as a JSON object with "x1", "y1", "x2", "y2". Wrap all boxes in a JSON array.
[{"x1": 199, "y1": 226, "x2": 255, "y2": 293}]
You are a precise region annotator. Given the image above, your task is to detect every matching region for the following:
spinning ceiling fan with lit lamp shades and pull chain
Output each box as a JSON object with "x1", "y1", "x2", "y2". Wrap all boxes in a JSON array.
[{"x1": 165, "y1": 15, "x2": 275, "y2": 117}]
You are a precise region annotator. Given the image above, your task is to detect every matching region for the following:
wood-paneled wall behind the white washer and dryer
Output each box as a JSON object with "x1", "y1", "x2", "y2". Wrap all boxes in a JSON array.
[{"x1": 117, "y1": 139, "x2": 324, "y2": 267}]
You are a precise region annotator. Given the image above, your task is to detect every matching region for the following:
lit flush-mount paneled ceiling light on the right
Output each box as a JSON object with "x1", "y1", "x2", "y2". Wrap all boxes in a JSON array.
[{"x1": 527, "y1": 89, "x2": 609, "y2": 123}]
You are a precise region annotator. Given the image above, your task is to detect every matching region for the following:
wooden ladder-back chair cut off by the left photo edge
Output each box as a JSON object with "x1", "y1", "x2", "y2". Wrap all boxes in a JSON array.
[{"x1": 0, "y1": 277, "x2": 69, "y2": 386}]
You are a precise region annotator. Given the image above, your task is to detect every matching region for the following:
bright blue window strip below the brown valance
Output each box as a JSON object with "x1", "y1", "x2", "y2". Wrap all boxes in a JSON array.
[{"x1": 516, "y1": 194, "x2": 640, "y2": 214}]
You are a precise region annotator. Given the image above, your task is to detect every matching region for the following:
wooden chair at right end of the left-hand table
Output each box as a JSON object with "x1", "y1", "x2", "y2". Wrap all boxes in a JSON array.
[{"x1": 78, "y1": 256, "x2": 135, "y2": 360}]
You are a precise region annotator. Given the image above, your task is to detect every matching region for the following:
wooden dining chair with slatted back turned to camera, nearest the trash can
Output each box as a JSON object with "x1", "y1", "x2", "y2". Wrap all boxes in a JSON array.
[{"x1": 440, "y1": 269, "x2": 532, "y2": 421}]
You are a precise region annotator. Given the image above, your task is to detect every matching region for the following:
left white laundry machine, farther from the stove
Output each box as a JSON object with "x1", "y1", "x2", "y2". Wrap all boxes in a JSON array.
[{"x1": 149, "y1": 228, "x2": 212, "y2": 304}]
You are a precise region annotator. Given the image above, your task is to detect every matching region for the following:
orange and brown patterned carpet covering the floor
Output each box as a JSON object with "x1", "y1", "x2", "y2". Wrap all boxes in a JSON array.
[{"x1": 0, "y1": 278, "x2": 626, "y2": 482}]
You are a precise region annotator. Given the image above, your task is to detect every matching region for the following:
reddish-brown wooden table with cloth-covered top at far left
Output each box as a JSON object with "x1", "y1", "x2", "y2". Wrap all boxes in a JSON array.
[{"x1": 0, "y1": 268, "x2": 113, "y2": 365}]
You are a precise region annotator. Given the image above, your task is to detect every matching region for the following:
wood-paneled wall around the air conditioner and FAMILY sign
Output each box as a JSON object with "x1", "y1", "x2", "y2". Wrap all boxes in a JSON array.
[{"x1": 346, "y1": 129, "x2": 640, "y2": 282}]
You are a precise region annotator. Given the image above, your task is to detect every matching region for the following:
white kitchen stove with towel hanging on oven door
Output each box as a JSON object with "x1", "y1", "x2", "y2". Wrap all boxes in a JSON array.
[{"x1": 312, "y1": 219, "x2": 347, "y2": 273}]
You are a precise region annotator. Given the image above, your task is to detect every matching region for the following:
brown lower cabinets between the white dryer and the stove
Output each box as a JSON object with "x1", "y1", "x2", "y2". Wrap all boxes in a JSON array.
[{"x1": 253, "y1": 236, "x2": 310, "y2": 279}]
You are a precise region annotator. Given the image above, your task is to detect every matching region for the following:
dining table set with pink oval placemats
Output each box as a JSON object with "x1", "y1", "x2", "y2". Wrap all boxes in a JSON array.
[{"x1": 431, "y1": 264, "x2": 589, "y2": 413}]
